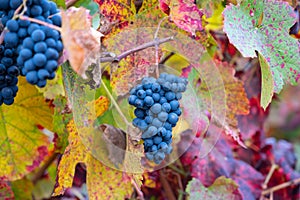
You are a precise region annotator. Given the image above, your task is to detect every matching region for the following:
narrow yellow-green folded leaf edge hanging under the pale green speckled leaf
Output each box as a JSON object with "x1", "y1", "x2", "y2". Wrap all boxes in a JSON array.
[{"x1": 258, "y1": 54, "x2": 274, "y2": 109}]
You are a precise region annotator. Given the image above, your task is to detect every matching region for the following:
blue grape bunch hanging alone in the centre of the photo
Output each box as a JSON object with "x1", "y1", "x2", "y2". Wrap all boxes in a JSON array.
[{"x1": 128, "y1": 73, "x2": 188, "y2": 164}]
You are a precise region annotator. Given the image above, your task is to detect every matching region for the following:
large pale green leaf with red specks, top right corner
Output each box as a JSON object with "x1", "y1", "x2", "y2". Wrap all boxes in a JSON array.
[{"x1": 223, "y1": 0, "x2": 300, "y2": 93}]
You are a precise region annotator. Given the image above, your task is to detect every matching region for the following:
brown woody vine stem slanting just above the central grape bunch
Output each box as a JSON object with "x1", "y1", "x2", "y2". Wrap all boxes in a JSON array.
[{"x1": 100, "y1": 36, "x2": 174, "y2": 63}]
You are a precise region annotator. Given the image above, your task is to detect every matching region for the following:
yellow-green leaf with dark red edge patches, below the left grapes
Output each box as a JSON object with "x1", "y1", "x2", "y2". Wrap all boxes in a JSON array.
[{"x1": 0, "y1": 78, "x2": 53, "y2": 180}]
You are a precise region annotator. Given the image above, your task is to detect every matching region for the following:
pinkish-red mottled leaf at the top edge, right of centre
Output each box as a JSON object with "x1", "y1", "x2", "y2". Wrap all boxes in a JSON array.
[{"x1": 160, "y1": 0, "x2": 203, "y2": 35}]
